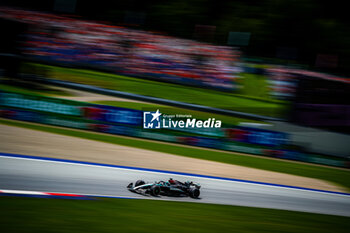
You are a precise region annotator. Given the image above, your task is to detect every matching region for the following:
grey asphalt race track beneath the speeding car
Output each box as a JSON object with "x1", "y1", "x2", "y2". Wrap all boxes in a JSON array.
[{"x1": 0, "y1": 156, "x2": 350, "y2": 217}]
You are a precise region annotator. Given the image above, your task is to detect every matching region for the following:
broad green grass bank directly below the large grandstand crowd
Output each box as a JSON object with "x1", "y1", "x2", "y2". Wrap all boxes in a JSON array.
[{"x1": 30, "y1": 64, "x2": 287, "y2": 116}]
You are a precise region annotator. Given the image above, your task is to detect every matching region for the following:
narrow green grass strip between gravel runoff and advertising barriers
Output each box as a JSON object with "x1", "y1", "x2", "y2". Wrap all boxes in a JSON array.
[{"x1": 0, "y1": 119, "x2": 350, "y2": 191}]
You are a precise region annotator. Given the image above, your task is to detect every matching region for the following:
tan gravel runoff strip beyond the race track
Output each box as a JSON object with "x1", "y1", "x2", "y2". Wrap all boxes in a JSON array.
[{"x1": 0, "y1": 124, "x2": 344, "y2": 192}]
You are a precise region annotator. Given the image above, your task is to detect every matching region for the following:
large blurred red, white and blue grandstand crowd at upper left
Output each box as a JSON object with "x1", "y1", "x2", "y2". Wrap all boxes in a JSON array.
[{"x1": 0, "y1": 8, "x2": 240, "y2": 90}]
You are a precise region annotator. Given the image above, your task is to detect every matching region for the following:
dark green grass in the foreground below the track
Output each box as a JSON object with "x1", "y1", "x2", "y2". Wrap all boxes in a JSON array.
[{"x1": 0, "y1": 197, "x2": 350, "y2": 233}]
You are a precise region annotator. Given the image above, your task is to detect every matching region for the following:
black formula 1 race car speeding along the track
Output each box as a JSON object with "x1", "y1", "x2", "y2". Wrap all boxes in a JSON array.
[{"x1": 127, "y1": 178, "x2": 201, "y2": 198}]
